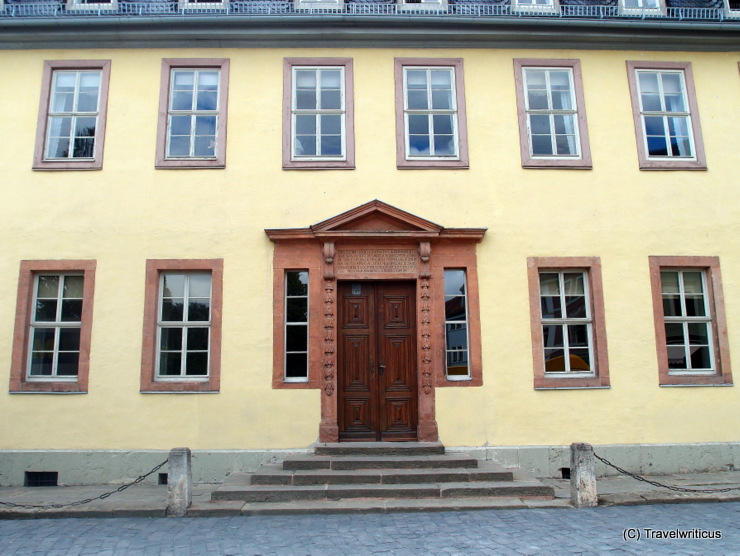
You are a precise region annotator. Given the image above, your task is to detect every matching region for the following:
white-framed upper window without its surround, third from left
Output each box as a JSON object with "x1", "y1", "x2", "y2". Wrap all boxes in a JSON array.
[{"x1": 291, "y1": 66, "x2": 346, "y2": 160}]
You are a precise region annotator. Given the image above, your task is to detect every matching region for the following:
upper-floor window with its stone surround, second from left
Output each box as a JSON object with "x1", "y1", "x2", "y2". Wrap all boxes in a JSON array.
[{"x1": 156, "y1": 59, "x2": 229, "y2": 168}]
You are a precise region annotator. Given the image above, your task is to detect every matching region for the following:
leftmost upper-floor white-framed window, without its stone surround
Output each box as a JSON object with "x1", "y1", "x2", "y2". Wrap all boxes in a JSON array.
[{"x1": 44, "y1": 70, "x2": 102, "y2": 160}]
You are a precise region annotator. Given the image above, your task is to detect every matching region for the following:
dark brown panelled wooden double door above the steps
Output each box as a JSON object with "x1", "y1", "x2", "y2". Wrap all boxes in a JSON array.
[{"x1": 337, "y1": 281, "x2": 418, "y2": 441}]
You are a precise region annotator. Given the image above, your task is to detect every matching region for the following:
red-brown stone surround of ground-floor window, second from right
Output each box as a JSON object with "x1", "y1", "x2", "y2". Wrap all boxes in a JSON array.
[{"x1": 527, "y1": 257, "x2": 610, "y2": 389}]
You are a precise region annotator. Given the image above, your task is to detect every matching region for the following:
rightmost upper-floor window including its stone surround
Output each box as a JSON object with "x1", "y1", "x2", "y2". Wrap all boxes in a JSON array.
[{"x1": 627, "y1": 61, "x2": 707, "y2": 170}]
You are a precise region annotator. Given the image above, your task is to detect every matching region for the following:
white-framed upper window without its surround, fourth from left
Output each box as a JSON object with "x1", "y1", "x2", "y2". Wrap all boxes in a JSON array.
[{"x1": 403, "y1": 66, "x2": 459, "y2": 160}]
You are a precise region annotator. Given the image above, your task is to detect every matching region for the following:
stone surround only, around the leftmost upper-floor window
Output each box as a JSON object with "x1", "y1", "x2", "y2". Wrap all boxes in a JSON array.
[{"x1": 33, "y1": 60, "x2": 111, "y2": 170}]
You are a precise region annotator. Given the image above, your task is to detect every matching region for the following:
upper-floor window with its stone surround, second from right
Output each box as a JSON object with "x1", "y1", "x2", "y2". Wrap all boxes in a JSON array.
[{"x1": 514, "y1": 59, "x2": 591, "y2": 169}]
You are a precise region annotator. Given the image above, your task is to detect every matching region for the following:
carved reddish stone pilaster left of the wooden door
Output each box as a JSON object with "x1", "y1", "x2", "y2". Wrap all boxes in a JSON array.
[{"x1": 319, "y1": 242, "x2": 339, "y2": 442}]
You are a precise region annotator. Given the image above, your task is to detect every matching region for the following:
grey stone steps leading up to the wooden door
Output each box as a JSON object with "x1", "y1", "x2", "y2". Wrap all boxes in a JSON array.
[{"x1": 208, "y1": 442, "x2": 554, "y2": 515}]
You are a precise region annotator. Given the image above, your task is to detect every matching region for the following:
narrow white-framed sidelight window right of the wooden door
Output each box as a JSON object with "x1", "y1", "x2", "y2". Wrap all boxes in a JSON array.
[{"x1": 444, "y1": 268, "x2": 470, "y2": 380}]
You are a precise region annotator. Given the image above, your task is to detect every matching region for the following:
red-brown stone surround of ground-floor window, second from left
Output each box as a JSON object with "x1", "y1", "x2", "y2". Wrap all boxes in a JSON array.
[{"x1": 141, "y1": 259, "x2": 224, "y2": 393}]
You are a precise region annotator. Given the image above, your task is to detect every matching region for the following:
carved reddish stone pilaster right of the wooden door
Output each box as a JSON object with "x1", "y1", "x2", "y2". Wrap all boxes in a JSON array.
[{"x1": 417, "y1": 241, "x2": 439, "y2": 442}]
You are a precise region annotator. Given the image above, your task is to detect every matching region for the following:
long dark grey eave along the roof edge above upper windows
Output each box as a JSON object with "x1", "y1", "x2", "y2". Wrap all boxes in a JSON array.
[{"x1": 0, "y1": 15, "x2": 740, "y2": 52}]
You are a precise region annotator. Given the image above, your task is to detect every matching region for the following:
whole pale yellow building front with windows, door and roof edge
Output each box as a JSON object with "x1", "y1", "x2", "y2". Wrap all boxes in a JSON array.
[{"x1": 0, "y1": 0, "x2": 740, "y2": 485}]
